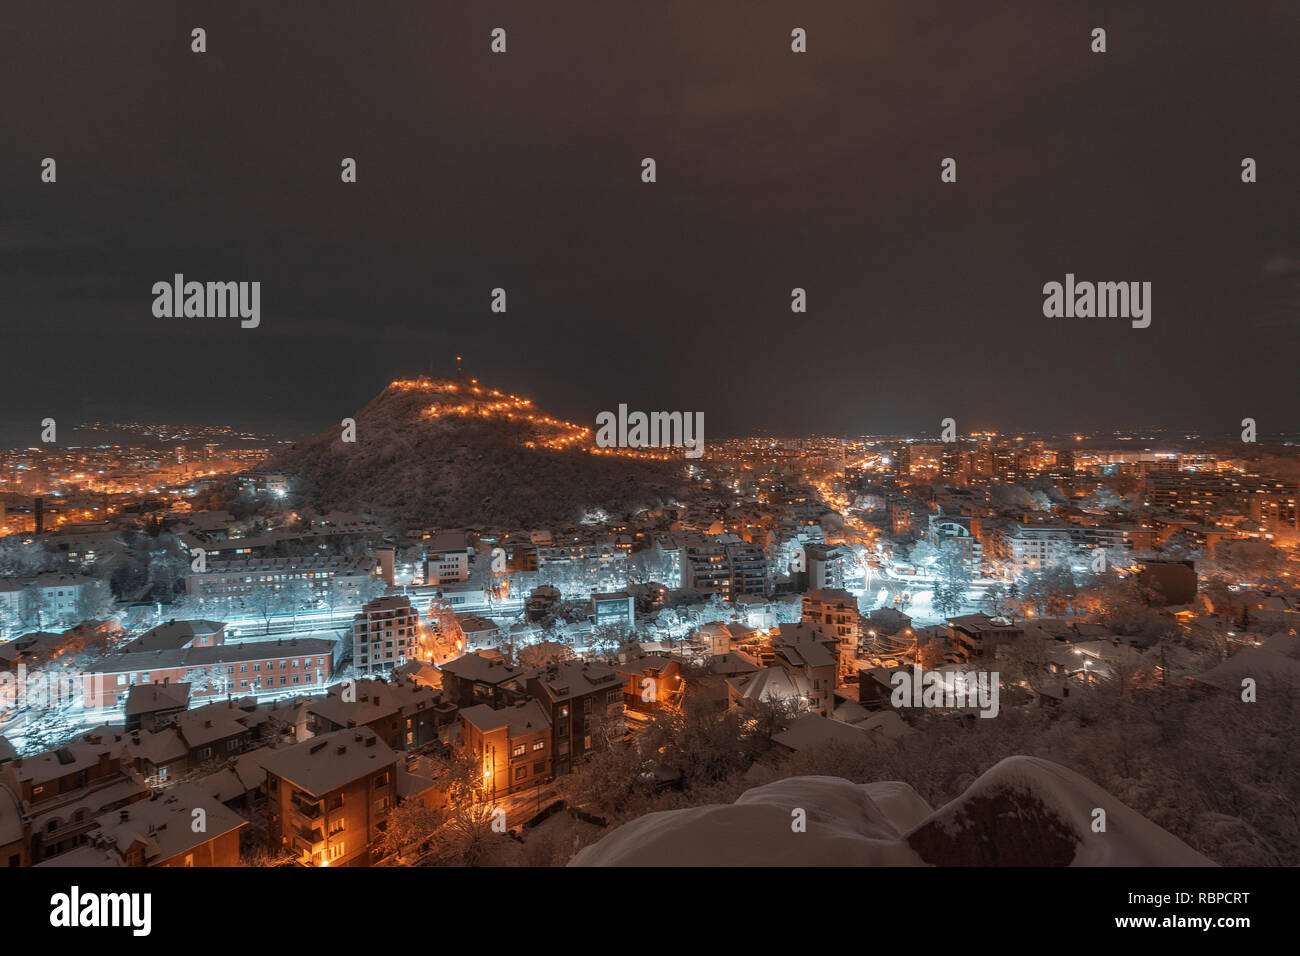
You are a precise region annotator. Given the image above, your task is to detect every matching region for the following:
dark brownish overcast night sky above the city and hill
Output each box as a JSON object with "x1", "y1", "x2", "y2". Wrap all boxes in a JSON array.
[{"x1": 0, "y1": 0, "x2": 1300, "y2": 444}]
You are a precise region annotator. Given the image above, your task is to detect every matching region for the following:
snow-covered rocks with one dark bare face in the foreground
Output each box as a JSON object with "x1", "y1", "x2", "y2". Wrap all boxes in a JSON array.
[{"x1": 569, "y1": 757, "x2": 1213, "y2": 866}]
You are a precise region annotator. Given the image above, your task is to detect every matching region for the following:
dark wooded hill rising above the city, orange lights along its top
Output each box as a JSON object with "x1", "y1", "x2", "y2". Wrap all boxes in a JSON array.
[{"x1": 267, "y1": 378, "x2": 683, "y2": 528}]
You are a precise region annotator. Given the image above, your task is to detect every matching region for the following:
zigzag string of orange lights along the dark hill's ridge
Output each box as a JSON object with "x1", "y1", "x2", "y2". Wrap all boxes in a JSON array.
[{"x1": 390, "y1": 376, "x2": 681, "y2": 460}]
